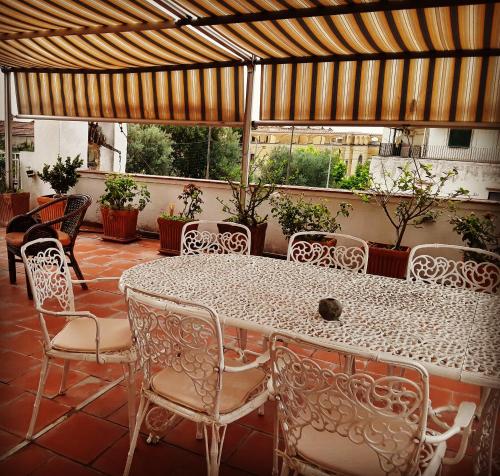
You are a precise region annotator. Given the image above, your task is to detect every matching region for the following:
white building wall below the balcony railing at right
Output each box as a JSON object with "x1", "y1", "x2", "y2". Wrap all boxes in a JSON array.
[{"x1": 370, "y1": 156, "x2": 500, "y2": 199}]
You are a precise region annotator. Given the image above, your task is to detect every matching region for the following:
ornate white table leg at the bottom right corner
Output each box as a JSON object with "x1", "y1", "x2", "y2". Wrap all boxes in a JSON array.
[{"x1": 474, "y1": 387, "x2": 500, "y2": 476}]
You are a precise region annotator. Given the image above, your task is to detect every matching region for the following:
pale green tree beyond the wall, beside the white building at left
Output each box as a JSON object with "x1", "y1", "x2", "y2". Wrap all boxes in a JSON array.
[{"x1": 126, "y1": 124, "x2": 173, "y2": 175}]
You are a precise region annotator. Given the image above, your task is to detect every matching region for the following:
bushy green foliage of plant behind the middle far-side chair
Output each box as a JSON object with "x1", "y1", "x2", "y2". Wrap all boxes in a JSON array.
[{"x1": 271, "y1": 193, "x2": 352, "y2": 246}]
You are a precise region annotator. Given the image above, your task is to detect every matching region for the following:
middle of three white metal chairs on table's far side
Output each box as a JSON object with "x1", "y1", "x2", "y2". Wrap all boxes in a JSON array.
[{"x1": 287, "y1": 231, "x2": 368, "y2": 274}]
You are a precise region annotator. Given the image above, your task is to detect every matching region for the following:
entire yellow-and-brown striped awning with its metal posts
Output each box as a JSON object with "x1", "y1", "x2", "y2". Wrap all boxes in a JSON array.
[{"x1": 0, "y1": 0, "x2": 500, "y2": 190}]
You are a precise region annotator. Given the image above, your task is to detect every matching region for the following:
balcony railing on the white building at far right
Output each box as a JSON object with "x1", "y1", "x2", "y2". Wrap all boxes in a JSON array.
[{"x1": 379, "y1": 143, "x2": 500, "y2": 164}]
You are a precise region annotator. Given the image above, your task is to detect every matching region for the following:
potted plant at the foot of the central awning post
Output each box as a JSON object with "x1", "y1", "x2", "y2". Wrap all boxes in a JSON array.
[{"x1": 217, "y1": 179, "x2": 275, "y2": 256}]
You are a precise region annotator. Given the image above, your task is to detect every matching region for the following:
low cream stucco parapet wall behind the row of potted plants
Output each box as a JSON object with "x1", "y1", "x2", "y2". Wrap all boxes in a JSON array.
[{"x1": 76, "y1": 171, "x2": 500, "y2": 254}]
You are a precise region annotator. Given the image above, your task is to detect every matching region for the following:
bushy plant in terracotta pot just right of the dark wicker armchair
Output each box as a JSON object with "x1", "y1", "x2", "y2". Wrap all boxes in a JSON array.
[{"x1": 98, "y1": 174, "x2": 150, "y2": 243}]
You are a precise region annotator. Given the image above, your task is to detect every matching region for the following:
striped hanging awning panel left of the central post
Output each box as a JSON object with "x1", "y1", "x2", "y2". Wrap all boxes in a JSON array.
[{"x1": 15, "y1": 66, "x2": 244, "y2": 123}]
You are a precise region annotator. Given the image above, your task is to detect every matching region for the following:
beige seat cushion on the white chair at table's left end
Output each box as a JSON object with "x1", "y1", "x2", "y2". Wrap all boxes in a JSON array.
[{"x1": 52, "y1": 317, "x2": 132, "y2": 352}]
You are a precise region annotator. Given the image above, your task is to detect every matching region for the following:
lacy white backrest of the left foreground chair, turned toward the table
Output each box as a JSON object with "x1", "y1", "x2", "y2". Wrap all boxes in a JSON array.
[{"x1": 126, "y1": 287, "x2": 224, "y2": 417}]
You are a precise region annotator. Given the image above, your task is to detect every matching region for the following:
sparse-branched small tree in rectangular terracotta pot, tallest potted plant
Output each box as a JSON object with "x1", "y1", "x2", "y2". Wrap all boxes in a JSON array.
[{"x1": 359, "y1": 159, "x2": 468, "y2": 279}]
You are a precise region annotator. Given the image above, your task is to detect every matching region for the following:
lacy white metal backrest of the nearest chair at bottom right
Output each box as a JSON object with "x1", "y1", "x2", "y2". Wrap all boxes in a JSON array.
[{"x1": 271, "y1": 333, "x2": 429, "y2": 475}]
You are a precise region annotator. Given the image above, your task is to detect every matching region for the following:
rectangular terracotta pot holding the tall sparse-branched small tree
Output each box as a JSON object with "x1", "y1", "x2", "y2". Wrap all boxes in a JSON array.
[{"x1": 368, "y1": 243, "x2": 410, "y2": 279}]
